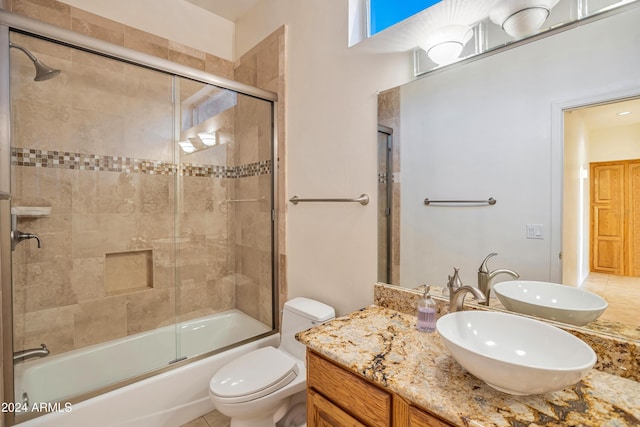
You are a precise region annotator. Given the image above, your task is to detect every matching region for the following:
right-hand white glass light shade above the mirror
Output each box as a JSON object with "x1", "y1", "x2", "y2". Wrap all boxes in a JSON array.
[{"x1": 489, "y1": 0, "x2": 559, "y2": 38}]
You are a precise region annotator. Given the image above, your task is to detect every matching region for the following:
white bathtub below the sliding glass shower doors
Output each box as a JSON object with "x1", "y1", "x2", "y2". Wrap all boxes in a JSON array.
[{"x1": 15, "y1": 310, "x2": 279, "y2": 427}]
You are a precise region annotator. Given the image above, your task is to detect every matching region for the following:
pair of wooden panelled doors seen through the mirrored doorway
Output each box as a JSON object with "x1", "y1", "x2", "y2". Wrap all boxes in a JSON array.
[{"x1": 591, "y1": 160, "x2": 640, "y2": 277}]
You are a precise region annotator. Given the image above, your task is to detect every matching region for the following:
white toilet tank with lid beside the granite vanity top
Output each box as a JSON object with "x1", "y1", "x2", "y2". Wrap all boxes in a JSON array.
[{"x1": 279, "y1": 297, "x2": 336, "y2": 361}]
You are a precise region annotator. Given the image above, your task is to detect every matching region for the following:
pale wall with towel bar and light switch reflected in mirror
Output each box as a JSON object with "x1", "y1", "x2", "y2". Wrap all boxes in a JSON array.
[{"x1": 401, "y1": 9, "x2": 640, "y2": 286}]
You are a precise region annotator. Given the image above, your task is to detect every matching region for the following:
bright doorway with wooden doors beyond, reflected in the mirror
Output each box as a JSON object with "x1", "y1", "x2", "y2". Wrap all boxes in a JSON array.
[{"x1": 562, "y1": 97, "x2": 640, "y2": 324}]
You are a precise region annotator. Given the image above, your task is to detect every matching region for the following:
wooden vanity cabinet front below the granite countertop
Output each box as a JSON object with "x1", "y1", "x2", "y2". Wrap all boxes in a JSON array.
[{"x1": 307, "y1": 350, "x2": 451, "y2": 427}]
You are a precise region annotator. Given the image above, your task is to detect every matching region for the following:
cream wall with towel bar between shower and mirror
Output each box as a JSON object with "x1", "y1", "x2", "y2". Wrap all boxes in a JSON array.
[{"x1": 236, "y1": 0, "x2": 411, "y2": 314}]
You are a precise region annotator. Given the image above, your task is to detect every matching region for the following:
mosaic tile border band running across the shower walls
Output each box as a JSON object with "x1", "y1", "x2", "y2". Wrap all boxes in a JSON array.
[{"x1": 11, "y1": 147, "x2": 273, "y2": 178}]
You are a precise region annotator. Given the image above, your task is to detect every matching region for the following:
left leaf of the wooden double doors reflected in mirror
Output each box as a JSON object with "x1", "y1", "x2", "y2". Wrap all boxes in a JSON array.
[{"x1": 591, "y1": 163, "x2": 624, "y2": 275}]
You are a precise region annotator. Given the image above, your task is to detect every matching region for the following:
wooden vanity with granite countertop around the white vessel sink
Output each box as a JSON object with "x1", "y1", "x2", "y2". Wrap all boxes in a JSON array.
[{"x1": 297, "y1": 305, "x2": 640, "y2": 427}]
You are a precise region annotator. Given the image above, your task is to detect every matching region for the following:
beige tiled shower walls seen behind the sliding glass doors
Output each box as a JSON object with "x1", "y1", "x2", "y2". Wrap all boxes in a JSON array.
[{"x1": 11, "y1": 28, "x2": 273, "y2": 367}]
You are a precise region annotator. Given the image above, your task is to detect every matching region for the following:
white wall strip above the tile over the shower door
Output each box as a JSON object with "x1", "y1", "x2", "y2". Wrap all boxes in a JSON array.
[{"x1": 61, "y1": 0, "x2": 235, "y2": 61}]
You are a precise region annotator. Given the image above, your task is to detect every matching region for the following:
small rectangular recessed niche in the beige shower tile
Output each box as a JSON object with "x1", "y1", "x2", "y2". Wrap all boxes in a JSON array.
[{"x1": 104, "y1": 249, "x2": 153, "y2": 296}]
